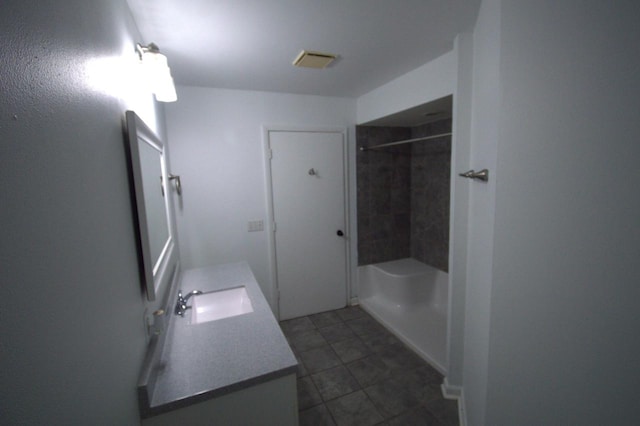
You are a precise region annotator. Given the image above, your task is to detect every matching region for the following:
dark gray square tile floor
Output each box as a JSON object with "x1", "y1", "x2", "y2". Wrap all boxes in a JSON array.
[{"x1": 280, "y1": 306, "x2": 459, "y2": 426}]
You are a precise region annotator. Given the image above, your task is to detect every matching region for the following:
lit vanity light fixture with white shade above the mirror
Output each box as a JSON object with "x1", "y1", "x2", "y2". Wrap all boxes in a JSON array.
[{"x1": 136, "y1": 43, "x2": 178, "y2": 102}]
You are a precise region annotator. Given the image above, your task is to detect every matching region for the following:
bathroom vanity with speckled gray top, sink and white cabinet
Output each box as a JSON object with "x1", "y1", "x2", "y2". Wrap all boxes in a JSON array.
[{"x1": 138, "y1": 262, "x2": 298, "y2": 426}]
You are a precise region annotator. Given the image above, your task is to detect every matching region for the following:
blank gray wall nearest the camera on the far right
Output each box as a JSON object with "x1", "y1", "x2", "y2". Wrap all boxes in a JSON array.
[{"x1": 486, "y1": 0, "x2": 640, "y2": 425}]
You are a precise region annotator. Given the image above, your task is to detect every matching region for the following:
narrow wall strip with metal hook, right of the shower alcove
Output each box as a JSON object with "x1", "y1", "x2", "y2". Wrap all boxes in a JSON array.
[{"x1": 462, "y1": 0, "x2": 501, "y2": 425}]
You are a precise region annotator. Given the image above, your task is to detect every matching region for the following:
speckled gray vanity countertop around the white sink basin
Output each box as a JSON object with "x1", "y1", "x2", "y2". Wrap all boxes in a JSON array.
[{"x1": 139, "y1": 262, "x2": 297, "y2": 417}]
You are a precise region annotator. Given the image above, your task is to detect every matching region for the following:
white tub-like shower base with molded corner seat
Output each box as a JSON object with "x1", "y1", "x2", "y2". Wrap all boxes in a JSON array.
[{"x1": 358, "y1": 258, "x2": 449, "y2": 375}]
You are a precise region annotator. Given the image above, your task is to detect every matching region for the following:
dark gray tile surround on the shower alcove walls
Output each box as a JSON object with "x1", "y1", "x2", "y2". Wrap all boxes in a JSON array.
[{"x1": 356, "y1": 119, "x2": 451, "y2": 271}]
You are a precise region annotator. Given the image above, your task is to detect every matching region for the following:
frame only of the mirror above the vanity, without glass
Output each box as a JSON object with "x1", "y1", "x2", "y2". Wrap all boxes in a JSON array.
[{"x1": 126, "y1": 111, "x2": 174, "y2": 301}]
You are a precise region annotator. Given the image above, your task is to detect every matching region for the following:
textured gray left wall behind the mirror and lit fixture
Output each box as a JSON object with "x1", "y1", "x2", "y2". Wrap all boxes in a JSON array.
[{"x1": 0, "y1": 0, "x2": 161, "y2": 425}]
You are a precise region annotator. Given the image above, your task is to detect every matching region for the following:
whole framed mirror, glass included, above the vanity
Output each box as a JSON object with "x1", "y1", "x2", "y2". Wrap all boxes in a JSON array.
[{"x1": 126, "y1": 111, "x2": 174, "y2": 301}]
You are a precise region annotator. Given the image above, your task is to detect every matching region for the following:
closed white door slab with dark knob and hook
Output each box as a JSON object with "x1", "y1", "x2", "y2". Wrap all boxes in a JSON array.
[{"x1": 269, "y1": 131, "x2": 347, "y2": 319}]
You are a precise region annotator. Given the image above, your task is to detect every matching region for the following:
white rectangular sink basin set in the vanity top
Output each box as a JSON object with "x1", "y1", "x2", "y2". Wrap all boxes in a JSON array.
[{"x1": 191, "y1": 286, "x2": 253, "y2": 324}]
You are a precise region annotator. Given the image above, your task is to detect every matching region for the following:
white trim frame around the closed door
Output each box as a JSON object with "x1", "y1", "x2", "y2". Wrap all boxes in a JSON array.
[{"x1": 262, "y1": 125, "x2": 352, "y2": 319}]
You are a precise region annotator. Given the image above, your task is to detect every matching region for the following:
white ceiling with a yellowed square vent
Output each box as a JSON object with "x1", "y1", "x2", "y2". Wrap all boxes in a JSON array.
[{"x1": 128, "y1": 0, "x2": 480, "y2": 97}]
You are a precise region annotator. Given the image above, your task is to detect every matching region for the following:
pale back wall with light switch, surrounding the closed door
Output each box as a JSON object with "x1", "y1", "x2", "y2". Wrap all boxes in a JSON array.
[{"x1": 165, "y1": 86, "x2": 356, "y2": 311}]
